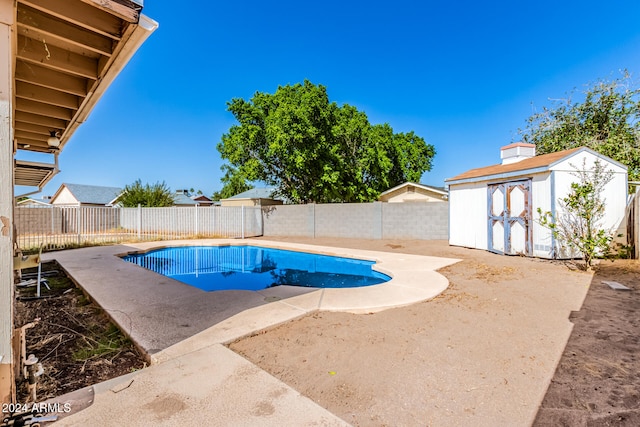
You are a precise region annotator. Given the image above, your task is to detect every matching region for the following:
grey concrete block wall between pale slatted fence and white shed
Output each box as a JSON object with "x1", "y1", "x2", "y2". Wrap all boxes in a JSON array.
[{"x1": 263, "y1": 202, "x2": 449, "y2": 240}]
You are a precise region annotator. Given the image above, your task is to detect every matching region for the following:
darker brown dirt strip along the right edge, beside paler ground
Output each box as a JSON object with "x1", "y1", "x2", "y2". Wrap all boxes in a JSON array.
[{"x1": 535, "y1": 260, "x2": 640, "y2": 426}]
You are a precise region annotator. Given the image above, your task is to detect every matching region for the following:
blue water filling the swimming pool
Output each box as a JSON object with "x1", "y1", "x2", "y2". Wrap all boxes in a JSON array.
[{"x1": 123, "y1": 246, "x2": 390, "y2": 291}]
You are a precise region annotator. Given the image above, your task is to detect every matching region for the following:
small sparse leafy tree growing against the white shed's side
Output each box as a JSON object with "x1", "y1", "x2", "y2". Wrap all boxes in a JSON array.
[{"x1": 538, "y1": 160, "x2": 613, "y2": 270}]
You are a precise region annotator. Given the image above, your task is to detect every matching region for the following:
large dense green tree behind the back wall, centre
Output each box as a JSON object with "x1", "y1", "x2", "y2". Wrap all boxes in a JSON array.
[{"x1": 218, "y1": 80, "x2": 435, "y2": 203}]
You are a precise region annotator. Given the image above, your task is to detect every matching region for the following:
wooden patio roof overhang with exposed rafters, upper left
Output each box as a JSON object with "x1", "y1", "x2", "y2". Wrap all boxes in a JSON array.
[{"x1": 12, "y1": 0, "x2": 157, "y2": 184}]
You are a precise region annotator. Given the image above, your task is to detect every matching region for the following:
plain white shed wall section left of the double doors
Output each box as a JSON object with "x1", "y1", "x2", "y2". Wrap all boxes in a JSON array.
[{"x1": 449, "y1": 182, "x2": 488, "y2": 250}]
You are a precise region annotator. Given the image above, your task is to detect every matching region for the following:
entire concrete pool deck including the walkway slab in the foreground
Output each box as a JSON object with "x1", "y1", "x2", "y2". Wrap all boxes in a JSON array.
[{"x1": 43, "y1": 239, "x2": 459, "y2": 425}]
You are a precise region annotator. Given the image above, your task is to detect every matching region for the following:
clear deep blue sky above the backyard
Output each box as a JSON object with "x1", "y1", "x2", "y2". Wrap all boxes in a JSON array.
[{"x1": 17, "y1": 0, "x2": 640, "y2": 199}]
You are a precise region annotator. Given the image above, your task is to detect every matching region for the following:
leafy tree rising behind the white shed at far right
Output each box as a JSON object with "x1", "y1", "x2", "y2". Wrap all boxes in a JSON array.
[{"x1": 520, "y1": 73, "x2": 640, "y2": 181}]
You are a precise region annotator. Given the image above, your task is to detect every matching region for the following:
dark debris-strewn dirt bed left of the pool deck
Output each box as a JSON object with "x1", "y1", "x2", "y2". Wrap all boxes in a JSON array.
[{"x1": 15, "y1": 262, "x2": 146, "y2": 402}]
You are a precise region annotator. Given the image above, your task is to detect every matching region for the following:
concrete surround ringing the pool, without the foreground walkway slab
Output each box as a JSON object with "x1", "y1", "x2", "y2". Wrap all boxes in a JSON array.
[{"x1": 43, "y1": 239, "x2": 459, "y2": 363}]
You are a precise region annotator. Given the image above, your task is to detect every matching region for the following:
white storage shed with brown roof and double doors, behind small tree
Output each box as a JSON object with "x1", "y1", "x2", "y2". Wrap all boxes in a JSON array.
[{"x1": 446, "y1": 142, "x2": 627, "y2": 258}]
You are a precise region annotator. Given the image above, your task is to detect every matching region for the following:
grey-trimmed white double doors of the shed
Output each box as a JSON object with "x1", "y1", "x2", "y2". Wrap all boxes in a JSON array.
[{"x1": 487, "y1": 179, "x2": 532, "y2": 256}]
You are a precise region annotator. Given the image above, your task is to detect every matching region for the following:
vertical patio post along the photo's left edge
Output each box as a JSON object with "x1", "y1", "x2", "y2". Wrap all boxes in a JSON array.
[{"x1": 0, "y1": 0, "x2": 16, "y2": 403}]
